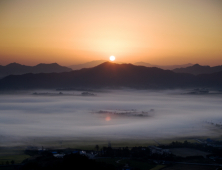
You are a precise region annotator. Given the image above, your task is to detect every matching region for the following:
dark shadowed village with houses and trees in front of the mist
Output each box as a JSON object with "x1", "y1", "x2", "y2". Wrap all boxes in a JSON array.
[{"x1": 1, "y1": 138, "x2": 222, "y2": 170}]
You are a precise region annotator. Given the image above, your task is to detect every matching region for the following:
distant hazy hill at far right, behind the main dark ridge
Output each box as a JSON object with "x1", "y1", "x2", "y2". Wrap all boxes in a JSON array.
[{"x1": 173, "y1": 64, "x2": 222, "y2": 75}]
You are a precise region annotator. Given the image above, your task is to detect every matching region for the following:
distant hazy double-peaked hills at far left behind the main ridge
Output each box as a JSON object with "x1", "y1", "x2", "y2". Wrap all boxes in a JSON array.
[{"x1": 0, "y1": 63, "x2": 72, "y2": 78}]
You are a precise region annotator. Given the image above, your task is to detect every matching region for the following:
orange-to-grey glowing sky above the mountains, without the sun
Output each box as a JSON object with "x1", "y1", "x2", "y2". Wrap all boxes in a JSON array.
[{"x1": 0, "y1": 0, "x2": 222, "y2": 66}]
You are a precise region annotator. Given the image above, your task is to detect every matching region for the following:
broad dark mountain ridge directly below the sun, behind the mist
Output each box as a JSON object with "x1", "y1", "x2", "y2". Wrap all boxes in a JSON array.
[{"x1": 0, "y1": 62, "x2": 222, "y2": 90}]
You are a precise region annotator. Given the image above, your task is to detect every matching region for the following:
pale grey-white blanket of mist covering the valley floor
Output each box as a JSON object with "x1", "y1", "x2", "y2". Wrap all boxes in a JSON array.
[{"x1": 0, "y1": 90, "x2": 222, "y2": 146}]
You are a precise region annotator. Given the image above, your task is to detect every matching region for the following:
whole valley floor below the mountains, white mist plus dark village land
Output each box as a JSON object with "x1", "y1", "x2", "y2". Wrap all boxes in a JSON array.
[{"x1": 0, "y1": 89, "x2": 222, "y2": 170}]
